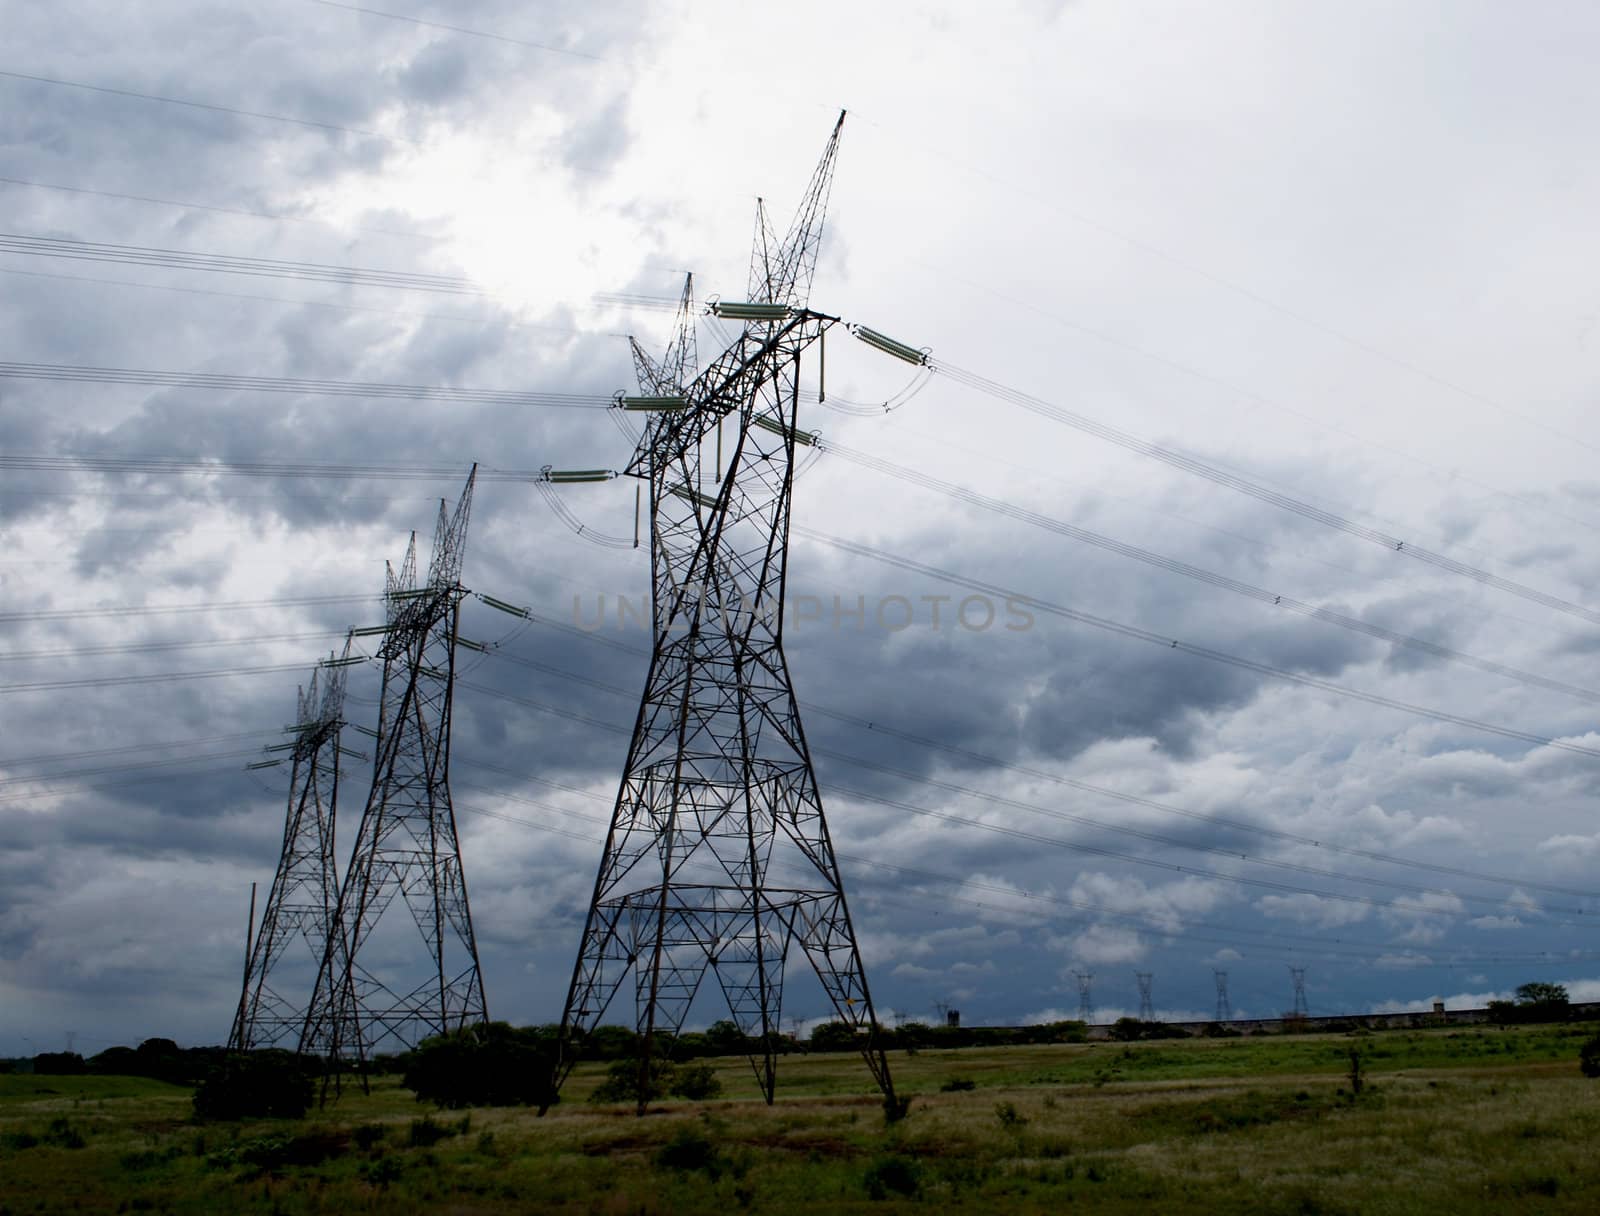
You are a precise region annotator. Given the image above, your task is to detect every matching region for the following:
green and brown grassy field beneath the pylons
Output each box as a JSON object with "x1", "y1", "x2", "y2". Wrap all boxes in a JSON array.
[{"x1": 0, "y1": 1026, "x2": 1600, "y2": 1216}]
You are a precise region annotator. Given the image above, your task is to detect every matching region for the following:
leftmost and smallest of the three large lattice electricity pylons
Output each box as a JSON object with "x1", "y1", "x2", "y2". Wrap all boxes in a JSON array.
[{"x1": 227, "y1": 640, "x2": 360, "y2": 1051}]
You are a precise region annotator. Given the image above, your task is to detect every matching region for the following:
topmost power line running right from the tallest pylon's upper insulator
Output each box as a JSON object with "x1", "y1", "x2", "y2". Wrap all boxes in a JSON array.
[{"x1": 936, "y1": 363, "x2": 1600, "y2": 624}]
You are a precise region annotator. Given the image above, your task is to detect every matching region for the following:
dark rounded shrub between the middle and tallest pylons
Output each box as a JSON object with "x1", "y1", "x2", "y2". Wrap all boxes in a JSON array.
[{"x1": 400, "y1": 1022, "x2": 555, "y2": 1109}]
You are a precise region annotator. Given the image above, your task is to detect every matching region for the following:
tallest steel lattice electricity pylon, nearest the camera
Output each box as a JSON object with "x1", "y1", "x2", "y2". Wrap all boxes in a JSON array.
[{"x1": 554, "y1": 115, "x2": 896, "y2": 1112}]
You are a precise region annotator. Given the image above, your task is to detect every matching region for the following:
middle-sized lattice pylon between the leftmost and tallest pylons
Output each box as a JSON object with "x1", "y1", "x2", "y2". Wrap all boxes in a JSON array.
[{"x1": 301, "y1": 466, "x2": 488, "y2": 1074}]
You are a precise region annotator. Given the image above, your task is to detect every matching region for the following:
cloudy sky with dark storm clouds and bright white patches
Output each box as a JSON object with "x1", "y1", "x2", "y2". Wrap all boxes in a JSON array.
[{"x1": 0, "y1": 0, "x2": 1600, "y2": 1054}]
